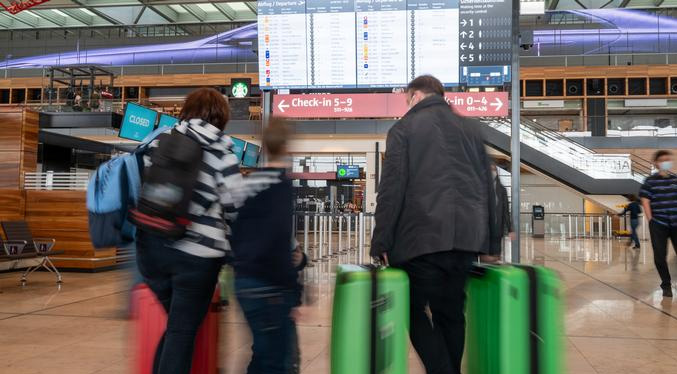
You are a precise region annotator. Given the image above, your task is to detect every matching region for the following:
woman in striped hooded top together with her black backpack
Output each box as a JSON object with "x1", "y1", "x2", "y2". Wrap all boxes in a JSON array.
[{"x1": 132, "y1": 88, "x2": 242, "y2": 374}]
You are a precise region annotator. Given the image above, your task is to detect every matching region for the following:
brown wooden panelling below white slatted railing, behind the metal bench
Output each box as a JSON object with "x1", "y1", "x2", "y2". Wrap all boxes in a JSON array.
[{"x1": 26, "y1": 191, "x2": 115, "y2": 269}]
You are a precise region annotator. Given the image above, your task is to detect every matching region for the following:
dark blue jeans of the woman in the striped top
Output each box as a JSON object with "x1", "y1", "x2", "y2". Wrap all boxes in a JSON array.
[{"x1": 137, "y1": 232, "x2": 223, "y2": 374}]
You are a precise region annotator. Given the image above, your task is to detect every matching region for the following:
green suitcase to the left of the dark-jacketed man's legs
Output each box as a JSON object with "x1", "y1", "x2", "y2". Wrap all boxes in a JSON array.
[{"x1": 331, "y1": 265, "x2": 409, "y2": 374}]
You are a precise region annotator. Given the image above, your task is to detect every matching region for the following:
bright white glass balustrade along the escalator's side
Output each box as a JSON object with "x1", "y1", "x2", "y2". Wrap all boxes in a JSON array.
[{"x1": 484, "y1": 118, "x2": 651, "y2": 182}]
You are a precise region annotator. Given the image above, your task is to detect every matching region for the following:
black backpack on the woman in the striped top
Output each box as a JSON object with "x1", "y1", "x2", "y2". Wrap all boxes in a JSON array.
[{"x1": 130, "y1": 129, "x2": 202, "y2": 240}]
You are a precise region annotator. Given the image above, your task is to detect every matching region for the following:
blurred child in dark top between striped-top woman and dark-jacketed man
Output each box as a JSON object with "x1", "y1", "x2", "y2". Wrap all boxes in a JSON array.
[{"x1": 232, "y1": 120, "x2": 299, "y2": 374}]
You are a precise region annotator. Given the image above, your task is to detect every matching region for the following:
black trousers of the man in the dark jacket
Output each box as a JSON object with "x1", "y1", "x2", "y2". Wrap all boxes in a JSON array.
[{"x1": 401, "y1": 251, "x2": 477, "y2": 374}]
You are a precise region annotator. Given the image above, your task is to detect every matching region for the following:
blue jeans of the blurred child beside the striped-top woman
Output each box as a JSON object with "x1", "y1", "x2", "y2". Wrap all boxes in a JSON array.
[{"x1": 235, "y1": 277, "x2": 294, "y2": 374}]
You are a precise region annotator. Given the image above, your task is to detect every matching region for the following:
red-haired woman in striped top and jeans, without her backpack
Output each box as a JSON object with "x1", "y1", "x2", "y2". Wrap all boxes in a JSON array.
[{"x1": 136, "y1": 88, "x2": 242, "y2": 374}]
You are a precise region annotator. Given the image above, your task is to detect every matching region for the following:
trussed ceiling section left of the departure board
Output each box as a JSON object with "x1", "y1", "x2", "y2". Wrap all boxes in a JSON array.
[{"x1": 0, "y1": 0, "x2": 256, "y2": 30}]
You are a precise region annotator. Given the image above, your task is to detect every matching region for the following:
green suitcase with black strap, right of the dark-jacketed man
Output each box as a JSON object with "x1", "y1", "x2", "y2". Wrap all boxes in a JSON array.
[{"x1": 466, "y1": 265, "x2": 564, "y2": 374}]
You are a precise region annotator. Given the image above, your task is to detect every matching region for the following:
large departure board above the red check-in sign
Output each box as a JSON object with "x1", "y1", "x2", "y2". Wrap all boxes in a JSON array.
[{"x1": 257, "y1": 0, "x2": 512, "y2": 89}]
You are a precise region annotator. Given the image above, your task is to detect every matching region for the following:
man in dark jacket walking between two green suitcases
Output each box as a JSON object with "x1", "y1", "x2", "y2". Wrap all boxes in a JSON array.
[{"x1": 371, "y1": 76, "x2": 499, "y2": 374}]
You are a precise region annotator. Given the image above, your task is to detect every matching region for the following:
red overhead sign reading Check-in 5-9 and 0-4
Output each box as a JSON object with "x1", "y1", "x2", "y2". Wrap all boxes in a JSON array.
[{"x1": 273, "y1": 92, "x2": 508, "y2": 118}]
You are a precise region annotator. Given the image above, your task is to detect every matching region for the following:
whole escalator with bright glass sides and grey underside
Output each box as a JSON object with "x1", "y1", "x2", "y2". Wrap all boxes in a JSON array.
[{"x1": 482, "y1": 118, "x2": 651, "y2": 195}]
